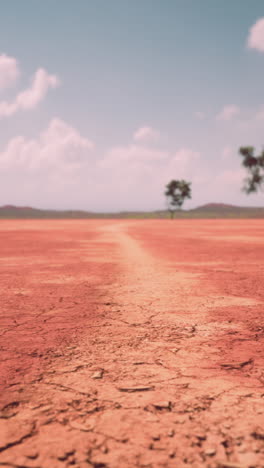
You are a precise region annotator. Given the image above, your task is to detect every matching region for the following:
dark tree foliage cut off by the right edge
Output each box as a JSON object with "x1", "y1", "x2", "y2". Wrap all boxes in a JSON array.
[{"x1": 239, "y1": 146, "x2": 264, "y2": 194}]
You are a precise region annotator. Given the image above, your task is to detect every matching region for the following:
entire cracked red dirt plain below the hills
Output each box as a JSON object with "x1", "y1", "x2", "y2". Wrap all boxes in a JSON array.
[{"x1": 0, "y1": 220, "x2": 264, "y2": 468}]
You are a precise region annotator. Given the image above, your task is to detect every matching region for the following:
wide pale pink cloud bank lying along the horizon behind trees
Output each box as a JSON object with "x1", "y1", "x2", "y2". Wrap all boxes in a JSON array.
[{"x1": 0, "y1": 118, "x2": 258, "y2": 211}]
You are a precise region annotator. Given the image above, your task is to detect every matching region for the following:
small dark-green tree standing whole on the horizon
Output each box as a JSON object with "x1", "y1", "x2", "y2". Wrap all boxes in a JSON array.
[{"x1": 165, "y1": 180, "x2": 191, "y2": 218}]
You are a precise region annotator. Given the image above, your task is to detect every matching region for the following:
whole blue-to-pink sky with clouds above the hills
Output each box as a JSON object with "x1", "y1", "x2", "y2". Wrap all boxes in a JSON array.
[{"x1": 0, "y1": 0, "x2": 264, "y2": 211}]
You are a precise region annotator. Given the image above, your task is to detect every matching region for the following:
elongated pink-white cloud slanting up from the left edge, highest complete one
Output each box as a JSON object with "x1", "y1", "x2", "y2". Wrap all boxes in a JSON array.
[{"x1": 0, "y1": 68, "x2": 59, "y2": 117}]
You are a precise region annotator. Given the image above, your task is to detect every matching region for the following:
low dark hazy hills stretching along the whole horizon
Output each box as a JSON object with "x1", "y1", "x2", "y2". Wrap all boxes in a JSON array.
[{"x1": 0, "y1": 203, "x2": 264, "y2": 219}]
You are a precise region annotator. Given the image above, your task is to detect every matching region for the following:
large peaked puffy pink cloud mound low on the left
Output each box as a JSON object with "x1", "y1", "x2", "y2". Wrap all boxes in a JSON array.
[{"x1": 0, "y1": 118, "x2": 94, "y2": 171}]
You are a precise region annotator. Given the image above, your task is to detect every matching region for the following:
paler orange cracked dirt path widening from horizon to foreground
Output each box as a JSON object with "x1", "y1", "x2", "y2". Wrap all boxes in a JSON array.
[{"x1": 0, "y1": 222, "x2": 264, "y2": 468}]
